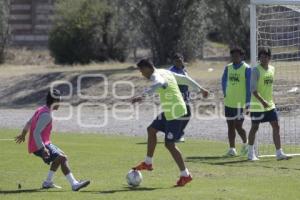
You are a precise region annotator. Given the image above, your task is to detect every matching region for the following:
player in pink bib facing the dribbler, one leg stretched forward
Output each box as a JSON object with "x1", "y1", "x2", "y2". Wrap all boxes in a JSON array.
[{"x1": 15, "y1": 90, "x2": 90, "y2": 191}]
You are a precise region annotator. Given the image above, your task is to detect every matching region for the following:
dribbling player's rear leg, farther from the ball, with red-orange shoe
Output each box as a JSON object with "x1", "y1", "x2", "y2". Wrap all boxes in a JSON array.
[{"x1": 165, "y1": 142, "x2": 192, "y2": 186}]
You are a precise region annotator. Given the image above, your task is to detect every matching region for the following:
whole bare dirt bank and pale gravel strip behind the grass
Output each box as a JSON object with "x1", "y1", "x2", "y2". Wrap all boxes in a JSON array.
[{"x1": 0, "y1": 62, "x2": 300, "y2": 150}]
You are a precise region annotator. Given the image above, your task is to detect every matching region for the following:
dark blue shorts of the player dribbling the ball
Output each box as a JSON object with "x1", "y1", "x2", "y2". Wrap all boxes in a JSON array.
[{"x1": 149, "y1": 110, "x2": 190, "y2": 143}]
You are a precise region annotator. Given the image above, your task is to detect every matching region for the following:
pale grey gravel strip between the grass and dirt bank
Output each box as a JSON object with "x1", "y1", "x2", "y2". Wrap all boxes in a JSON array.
[{"x1": 0, "y1": 104, "x2": 300, "y2": 144}]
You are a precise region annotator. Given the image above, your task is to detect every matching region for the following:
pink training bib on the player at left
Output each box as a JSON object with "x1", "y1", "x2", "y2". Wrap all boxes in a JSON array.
[{"x1": 28, "y1": 106, "x2": 52, "y2": 153}]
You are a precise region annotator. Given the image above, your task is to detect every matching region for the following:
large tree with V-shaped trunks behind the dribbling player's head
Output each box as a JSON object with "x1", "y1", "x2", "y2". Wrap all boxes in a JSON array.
[{"x1": 125, "y1": 0, "x2": 207, "y2": 64}]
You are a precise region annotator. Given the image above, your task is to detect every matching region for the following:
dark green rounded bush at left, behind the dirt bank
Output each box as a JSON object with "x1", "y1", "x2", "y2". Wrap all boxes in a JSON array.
[{"x1": 49, "y1": 0, "x2": 128, "y2": 64}]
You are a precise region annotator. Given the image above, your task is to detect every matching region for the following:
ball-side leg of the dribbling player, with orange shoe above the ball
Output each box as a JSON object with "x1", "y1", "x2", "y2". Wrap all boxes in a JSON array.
[{"x1": 132, "y1": 126, "x2": 158, "y2": 171}]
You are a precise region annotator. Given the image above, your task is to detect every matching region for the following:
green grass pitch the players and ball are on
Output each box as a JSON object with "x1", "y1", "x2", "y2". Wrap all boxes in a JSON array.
[{"x1": 0, "y1": 130, "x2": 300, "y2": 200}]
